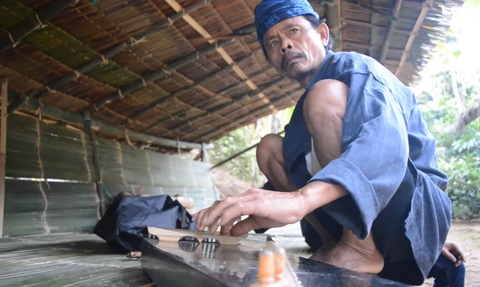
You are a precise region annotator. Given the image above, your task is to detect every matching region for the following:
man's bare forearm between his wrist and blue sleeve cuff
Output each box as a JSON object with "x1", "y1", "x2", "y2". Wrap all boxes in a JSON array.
[{"x1": 298, "y1": 181, "x2": 348, "y2": 214}]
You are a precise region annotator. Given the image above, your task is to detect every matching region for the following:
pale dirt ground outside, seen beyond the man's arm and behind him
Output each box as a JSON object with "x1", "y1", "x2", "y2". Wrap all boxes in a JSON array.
[{"x1": 214, "y1": 169, "x2": 480, "y2": 287}]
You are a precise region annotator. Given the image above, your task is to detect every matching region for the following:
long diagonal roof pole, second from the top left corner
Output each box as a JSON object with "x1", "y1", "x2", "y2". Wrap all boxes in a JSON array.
[{"x1": 9, "y1": 0, "x2": 213, "y2": 113}]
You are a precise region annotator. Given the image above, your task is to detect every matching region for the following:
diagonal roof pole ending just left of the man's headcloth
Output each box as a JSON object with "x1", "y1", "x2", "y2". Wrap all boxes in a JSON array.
[{"x1": 82, "y1": 40, "x2": 236, "y2": 113}]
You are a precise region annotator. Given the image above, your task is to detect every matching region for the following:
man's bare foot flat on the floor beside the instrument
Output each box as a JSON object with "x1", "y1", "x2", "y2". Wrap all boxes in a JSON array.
[{"x1": 310, "y1": 230, "x2": 384, "y2": 274}]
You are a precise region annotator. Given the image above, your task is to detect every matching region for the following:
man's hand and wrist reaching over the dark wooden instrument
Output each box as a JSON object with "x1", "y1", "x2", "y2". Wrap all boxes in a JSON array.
[{"x1": 193, "y1": 188, "x2": 306, "y2": 236}]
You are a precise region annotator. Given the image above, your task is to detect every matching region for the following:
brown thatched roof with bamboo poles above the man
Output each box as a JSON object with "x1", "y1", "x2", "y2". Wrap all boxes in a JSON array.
[{"x1": 0, "y1": 0, "x2": 462, "y2": 150}]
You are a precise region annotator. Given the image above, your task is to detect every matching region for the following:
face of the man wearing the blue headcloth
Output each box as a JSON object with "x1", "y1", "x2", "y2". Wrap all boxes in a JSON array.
[{"x1": 263, "y1": 16, "x2": 329, "y2": 81}]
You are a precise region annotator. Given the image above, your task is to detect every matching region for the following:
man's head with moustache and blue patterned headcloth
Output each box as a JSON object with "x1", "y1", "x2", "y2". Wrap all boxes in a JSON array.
[{"x1": 255, "y1": 0, "x2": 330, "y2": 84}]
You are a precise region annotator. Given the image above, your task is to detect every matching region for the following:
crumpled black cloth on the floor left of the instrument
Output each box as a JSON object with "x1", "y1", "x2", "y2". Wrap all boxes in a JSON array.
[{"x1": 93, "y1": 195, "x2": 197, "y2": 252}]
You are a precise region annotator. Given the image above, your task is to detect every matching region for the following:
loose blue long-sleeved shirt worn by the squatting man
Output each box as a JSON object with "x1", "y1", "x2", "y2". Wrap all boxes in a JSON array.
[{"x1": 264, "y1": 52, "x2": 451, "y2": 278}]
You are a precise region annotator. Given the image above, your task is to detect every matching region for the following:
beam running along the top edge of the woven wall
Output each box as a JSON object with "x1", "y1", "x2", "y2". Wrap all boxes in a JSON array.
[{"x1": 7, "y1": 91, "x2": 206, "y2": 149}]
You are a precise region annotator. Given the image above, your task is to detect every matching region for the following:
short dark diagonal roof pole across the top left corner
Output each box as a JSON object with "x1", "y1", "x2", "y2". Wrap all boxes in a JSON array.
[{"x1": 0, "y1": 0, "x2": 77, "y2": 52}]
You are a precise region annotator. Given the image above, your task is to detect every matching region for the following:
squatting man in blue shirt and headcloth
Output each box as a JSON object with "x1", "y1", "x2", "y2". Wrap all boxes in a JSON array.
[{"x1": 193, "y1": 0, "x2": 451, "y2": 284}]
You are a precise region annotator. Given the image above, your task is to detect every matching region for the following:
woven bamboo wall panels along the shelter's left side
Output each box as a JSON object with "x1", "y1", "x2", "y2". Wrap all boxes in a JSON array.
[{"x1": 4, "y1": 115, "x2": 217, "y2": 236}]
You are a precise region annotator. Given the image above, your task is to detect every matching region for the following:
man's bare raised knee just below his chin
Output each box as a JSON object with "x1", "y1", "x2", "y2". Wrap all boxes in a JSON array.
[{"x1": 303, "y1": 80, "x2": 348, "y2": 125}]
